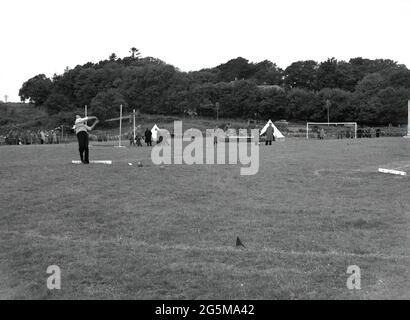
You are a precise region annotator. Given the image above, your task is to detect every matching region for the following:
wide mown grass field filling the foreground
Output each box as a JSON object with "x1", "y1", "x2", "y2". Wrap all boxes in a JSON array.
[{"x1": 0, "y1": 138, "x2": 410, "y2": 299}]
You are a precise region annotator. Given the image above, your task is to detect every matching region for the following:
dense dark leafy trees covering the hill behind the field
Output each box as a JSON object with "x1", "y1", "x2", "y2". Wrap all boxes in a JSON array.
[{"x1": 19, "y1": 48, "x2": 410, "y2": 125}]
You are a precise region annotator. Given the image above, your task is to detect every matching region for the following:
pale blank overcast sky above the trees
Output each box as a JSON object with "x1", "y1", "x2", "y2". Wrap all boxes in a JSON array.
[{"x1": 0, "y1": 0, "x2": 410, "y2": 101}]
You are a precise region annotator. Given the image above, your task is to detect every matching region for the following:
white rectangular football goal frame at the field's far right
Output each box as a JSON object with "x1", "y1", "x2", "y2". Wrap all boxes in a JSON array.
[{"x1": 306, "y1": 122, "x2": 357, "y2": 139}]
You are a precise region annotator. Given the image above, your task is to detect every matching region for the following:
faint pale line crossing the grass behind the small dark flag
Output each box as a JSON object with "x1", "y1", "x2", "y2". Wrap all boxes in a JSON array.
[{"x1": 0, "y1": 231, "x2": 410, "y2": 260}]
